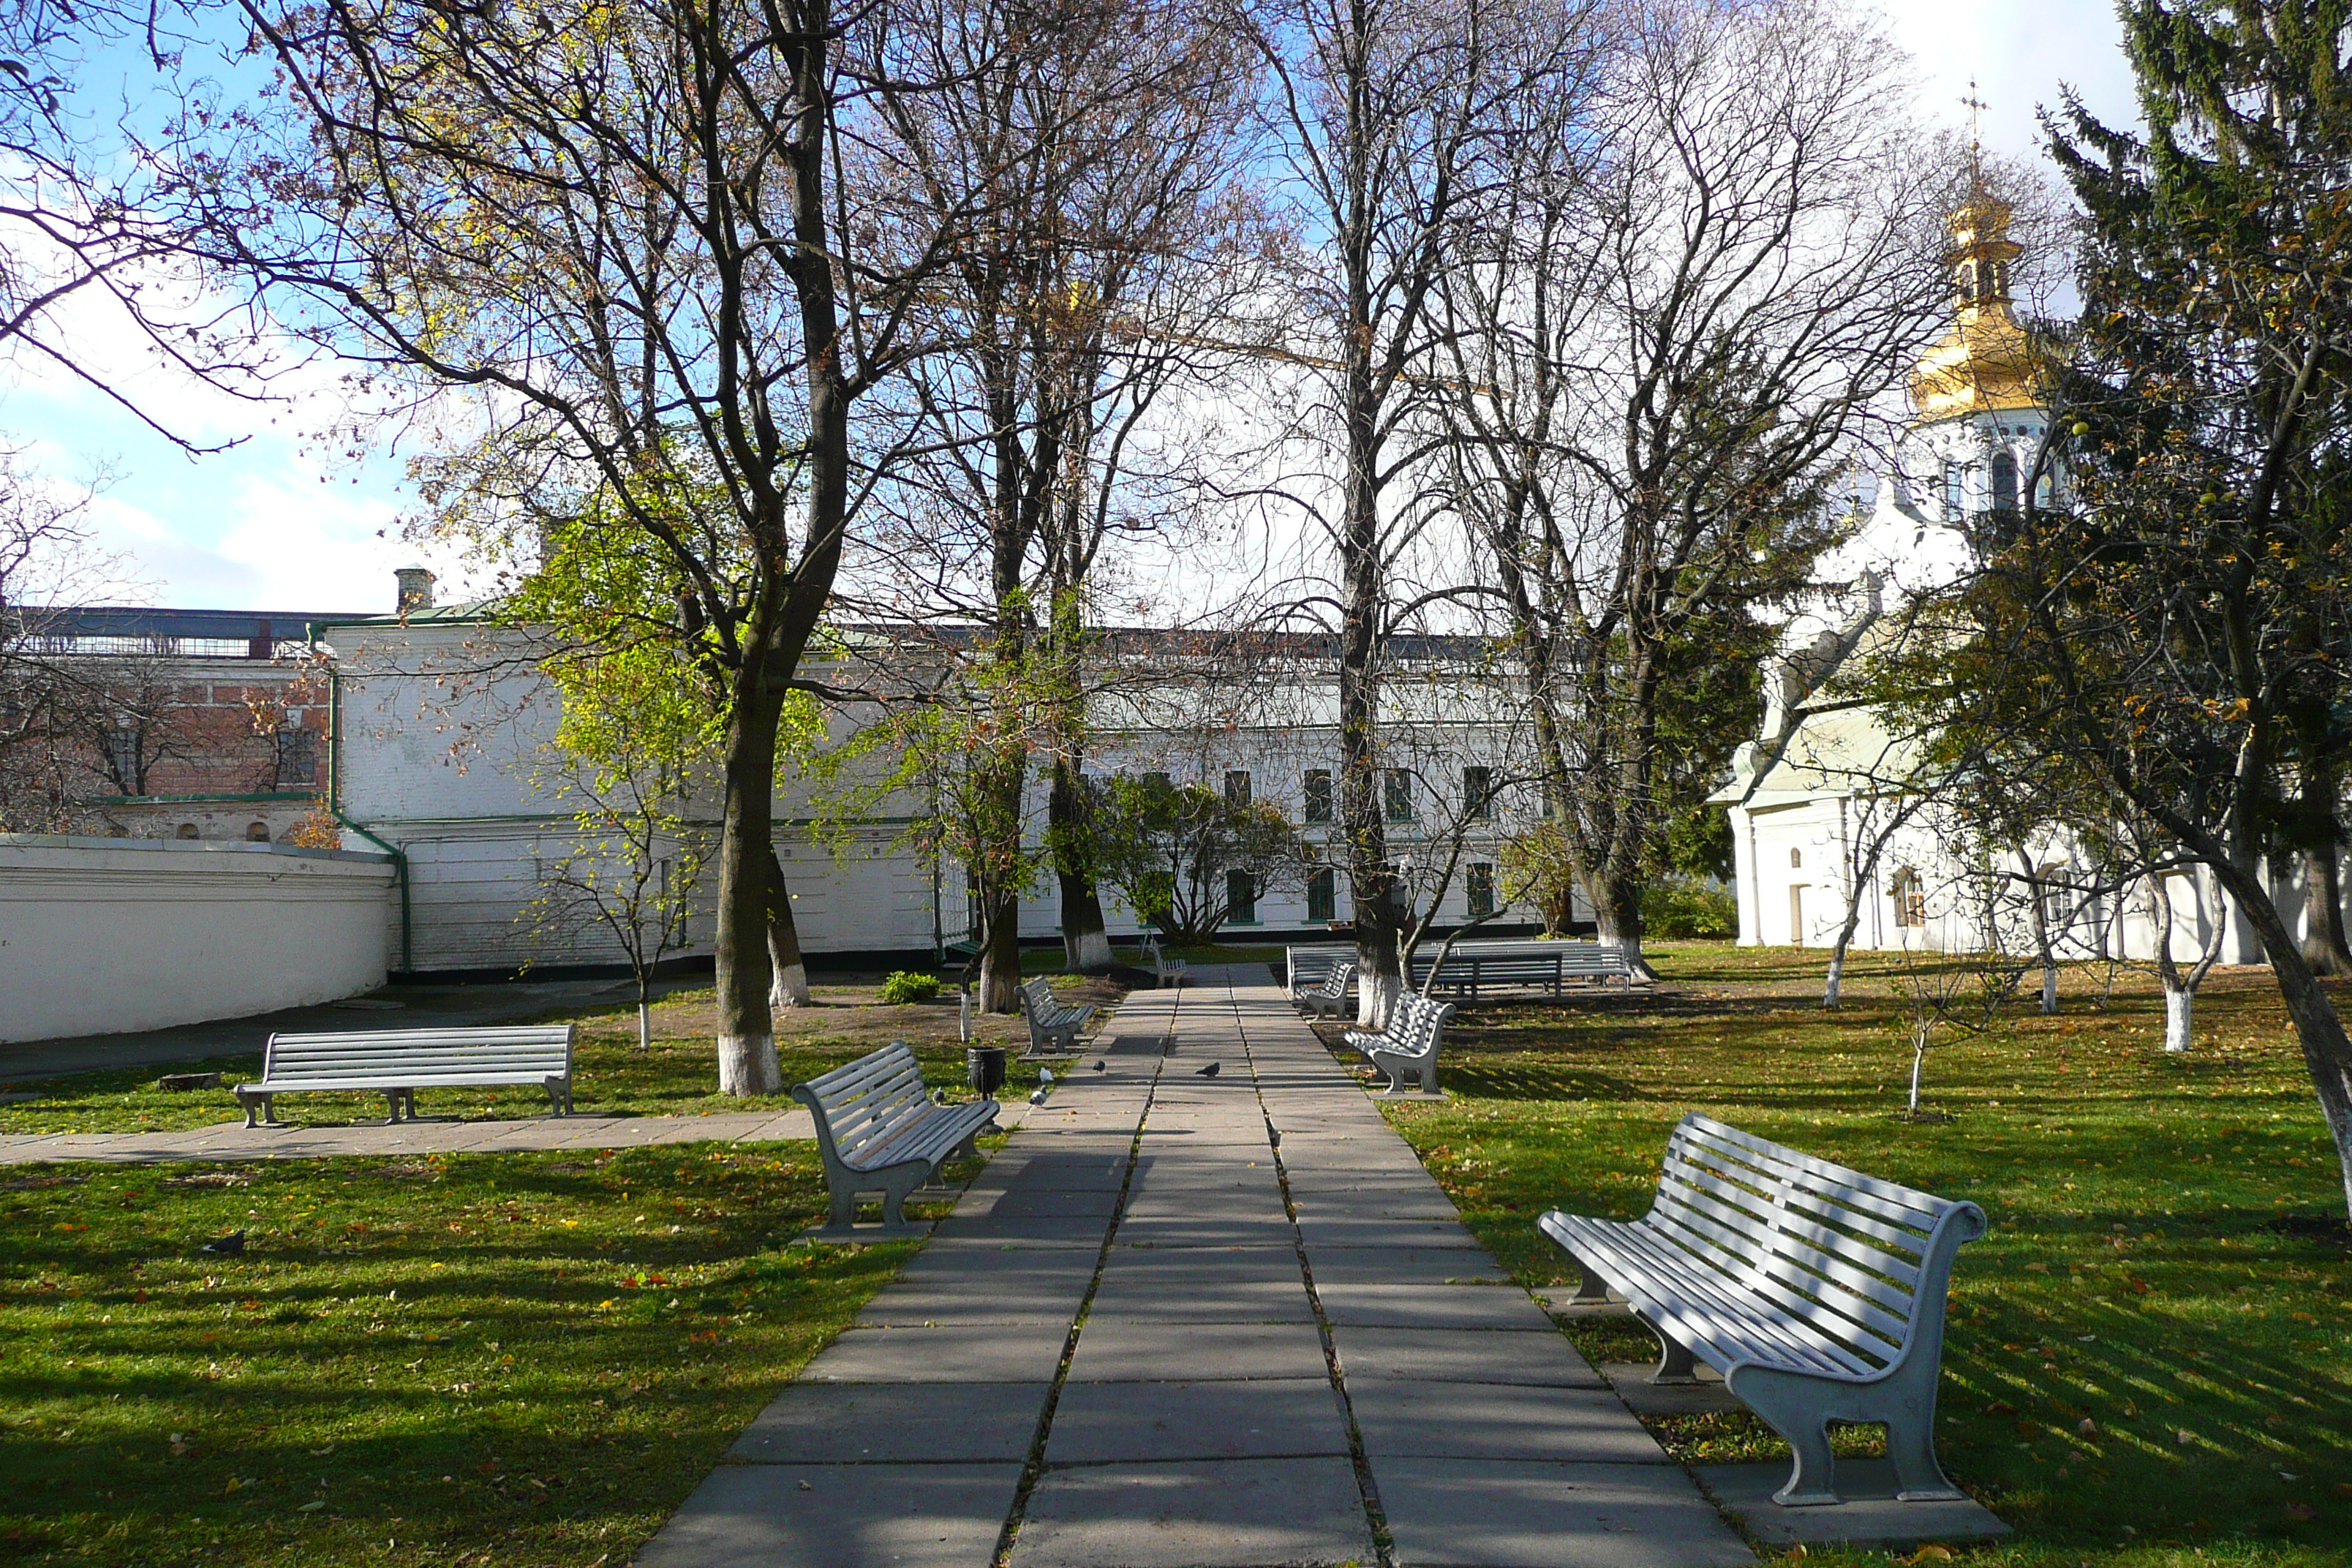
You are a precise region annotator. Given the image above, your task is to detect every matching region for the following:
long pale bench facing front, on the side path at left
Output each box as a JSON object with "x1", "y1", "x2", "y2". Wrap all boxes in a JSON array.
[{"x1": 235, "y1": 1022, "x2": 571, "y2": 1126}]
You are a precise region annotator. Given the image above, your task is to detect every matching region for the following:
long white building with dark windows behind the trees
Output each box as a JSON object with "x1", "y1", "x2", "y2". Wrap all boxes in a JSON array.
[{"x1": 320, "y1": 585, "x2": 1536, "y2": 976}]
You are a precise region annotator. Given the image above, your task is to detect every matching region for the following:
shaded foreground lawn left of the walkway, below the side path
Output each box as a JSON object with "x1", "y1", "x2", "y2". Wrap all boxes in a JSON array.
[{"x1": 0, "y1": 1142, "x2": 987, "y2": 1568}]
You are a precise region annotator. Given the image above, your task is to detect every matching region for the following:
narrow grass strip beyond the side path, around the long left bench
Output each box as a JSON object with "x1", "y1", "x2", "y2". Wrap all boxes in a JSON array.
[{"x1": 0, "y1": 980, "x2": 1082, "y2": 1136}]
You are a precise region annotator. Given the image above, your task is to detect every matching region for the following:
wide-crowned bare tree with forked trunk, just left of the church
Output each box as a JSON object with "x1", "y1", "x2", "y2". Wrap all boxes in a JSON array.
[{"x1": 1444, "y1": 0, "x2": 1938, "y2": 959}]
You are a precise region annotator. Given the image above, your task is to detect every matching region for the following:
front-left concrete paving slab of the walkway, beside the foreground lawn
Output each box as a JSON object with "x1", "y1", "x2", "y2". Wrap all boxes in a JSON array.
[{"x1": 635, "y1": 1462, "x2": 1021, "y2": 1568}]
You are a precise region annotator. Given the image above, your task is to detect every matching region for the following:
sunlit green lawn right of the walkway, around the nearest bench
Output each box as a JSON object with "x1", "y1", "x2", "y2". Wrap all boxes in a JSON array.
[{"x1": 1345, "y1": 943, "x2": 2352, "y2": 1568}]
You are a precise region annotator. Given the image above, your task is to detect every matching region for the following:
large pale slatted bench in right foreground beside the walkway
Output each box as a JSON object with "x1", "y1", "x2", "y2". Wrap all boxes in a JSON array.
[{"x1": 1538, "y1": 1115, "x2": 1985, "y2": 1507}]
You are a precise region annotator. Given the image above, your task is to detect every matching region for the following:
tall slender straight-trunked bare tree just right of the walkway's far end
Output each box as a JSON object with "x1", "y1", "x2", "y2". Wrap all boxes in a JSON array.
[{"x1": 1246, "y1": 0, "x2": 1590, "y2": 1025}]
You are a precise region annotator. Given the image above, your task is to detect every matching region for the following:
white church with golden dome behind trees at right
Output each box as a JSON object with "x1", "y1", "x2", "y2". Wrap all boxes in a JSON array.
[{"x1": 1712, "y1": 184, "x2": 2258, "y2": 962}]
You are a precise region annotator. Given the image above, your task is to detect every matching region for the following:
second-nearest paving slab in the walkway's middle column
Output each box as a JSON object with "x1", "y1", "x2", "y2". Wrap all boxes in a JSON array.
[{"x1": 1044, "y1": 1382, "x2": 1348, "y2": 1465}]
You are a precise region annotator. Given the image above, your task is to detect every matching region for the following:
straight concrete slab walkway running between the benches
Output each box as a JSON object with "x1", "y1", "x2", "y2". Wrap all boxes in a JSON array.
[{"x1": 640, "y1": 966, "x2": 1754, "y2": 1568}]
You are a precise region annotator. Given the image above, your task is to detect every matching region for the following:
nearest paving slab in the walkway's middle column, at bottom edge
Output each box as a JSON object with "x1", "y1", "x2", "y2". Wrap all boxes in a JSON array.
[{"x1": 1011, "y1": 1458, "x2": 1373, "y2": 1568}]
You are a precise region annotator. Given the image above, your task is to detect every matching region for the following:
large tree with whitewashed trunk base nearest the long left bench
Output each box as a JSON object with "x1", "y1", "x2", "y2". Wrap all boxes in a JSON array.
[{"x1": 183, "y1": 0, "x2": 1058, "y2": 1093}]
